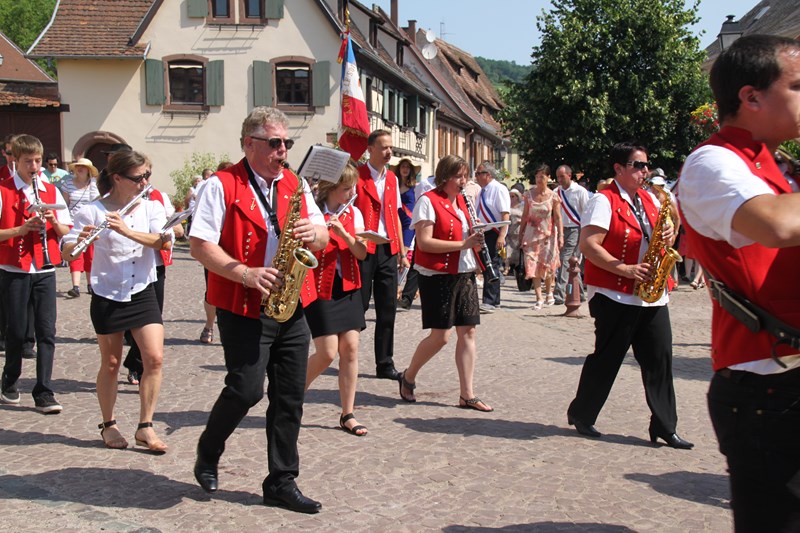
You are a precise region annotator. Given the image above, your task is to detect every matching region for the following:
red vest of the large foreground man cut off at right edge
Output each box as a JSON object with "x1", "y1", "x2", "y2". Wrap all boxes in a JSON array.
[{"x1": 682, "y1": 127, "x2": 800, "y2": 370}]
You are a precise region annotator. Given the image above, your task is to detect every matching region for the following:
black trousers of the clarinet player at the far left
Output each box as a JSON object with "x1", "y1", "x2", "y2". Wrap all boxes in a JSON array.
[{"x1": 0, "y1": 271, "x2": 56, "y2": 398}]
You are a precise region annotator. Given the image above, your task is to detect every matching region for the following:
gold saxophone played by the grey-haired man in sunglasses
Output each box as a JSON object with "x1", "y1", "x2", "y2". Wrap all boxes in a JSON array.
[{"x1": 261, "y1": 178, "x2": 319, "y2": 322}]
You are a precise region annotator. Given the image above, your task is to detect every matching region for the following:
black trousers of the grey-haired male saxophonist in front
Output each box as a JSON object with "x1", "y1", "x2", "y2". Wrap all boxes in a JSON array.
[{"x1": 198, "y1": 305, "x2": 311, "y2": 491}]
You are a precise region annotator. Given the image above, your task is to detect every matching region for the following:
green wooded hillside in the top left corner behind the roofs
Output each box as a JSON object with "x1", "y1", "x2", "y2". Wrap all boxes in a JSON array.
[{"x1": 0, "y1": 0, "x2": 56, "y2": 76}]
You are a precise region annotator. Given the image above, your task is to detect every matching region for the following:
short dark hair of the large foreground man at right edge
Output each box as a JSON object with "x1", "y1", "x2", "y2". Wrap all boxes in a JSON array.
[{"x1": 709, "y1": 34, "x2": 800, "y2": 119}]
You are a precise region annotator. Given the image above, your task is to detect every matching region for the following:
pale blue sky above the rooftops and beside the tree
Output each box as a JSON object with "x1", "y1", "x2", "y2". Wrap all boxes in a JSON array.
[{"x1": 376, "y1": 0, "x2": 758, "y2": 64}]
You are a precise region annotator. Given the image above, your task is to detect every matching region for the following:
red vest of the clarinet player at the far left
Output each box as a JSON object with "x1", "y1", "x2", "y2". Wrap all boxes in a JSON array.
[{"x1": 0, "y1": 179, "x2": 61, "y2": 272}]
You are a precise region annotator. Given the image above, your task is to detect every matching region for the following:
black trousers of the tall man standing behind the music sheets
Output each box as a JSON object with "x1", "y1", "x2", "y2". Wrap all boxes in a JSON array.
[{"x1": 359, "y1": 243, "x2": 397, "y2": 370}]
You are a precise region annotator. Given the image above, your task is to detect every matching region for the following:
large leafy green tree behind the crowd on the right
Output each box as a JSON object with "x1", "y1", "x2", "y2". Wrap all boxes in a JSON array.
[{"x1": 501, "y1": 0, "x2": 710, "y2": 180}]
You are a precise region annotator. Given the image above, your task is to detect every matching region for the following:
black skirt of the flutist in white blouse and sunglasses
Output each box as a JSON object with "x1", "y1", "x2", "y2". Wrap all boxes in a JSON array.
[{"x1": 89, "y1": 283, "x2": 163, "y2": 335}]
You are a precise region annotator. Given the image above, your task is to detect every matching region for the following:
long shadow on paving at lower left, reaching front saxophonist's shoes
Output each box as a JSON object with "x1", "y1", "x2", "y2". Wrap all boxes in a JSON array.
[{"x1": 0, "y1": 468, "x2": 262, "y2": 510}]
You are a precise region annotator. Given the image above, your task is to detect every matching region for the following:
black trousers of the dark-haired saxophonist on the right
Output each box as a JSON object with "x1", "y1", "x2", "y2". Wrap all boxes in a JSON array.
[{"x1": 567, "y1": 294, "x2": 678, "y2": 435}]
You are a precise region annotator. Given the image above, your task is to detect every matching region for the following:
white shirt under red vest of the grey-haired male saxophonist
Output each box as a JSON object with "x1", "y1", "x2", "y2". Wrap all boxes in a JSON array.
[{"x1": 189, "y1": 168, "x2": 325, "y2": 266}]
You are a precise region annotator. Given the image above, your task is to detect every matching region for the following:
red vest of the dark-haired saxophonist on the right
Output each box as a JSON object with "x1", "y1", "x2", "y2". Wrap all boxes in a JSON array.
[{"x1": 584, "y1": 181, "x2": 672, "y2": 294}]
